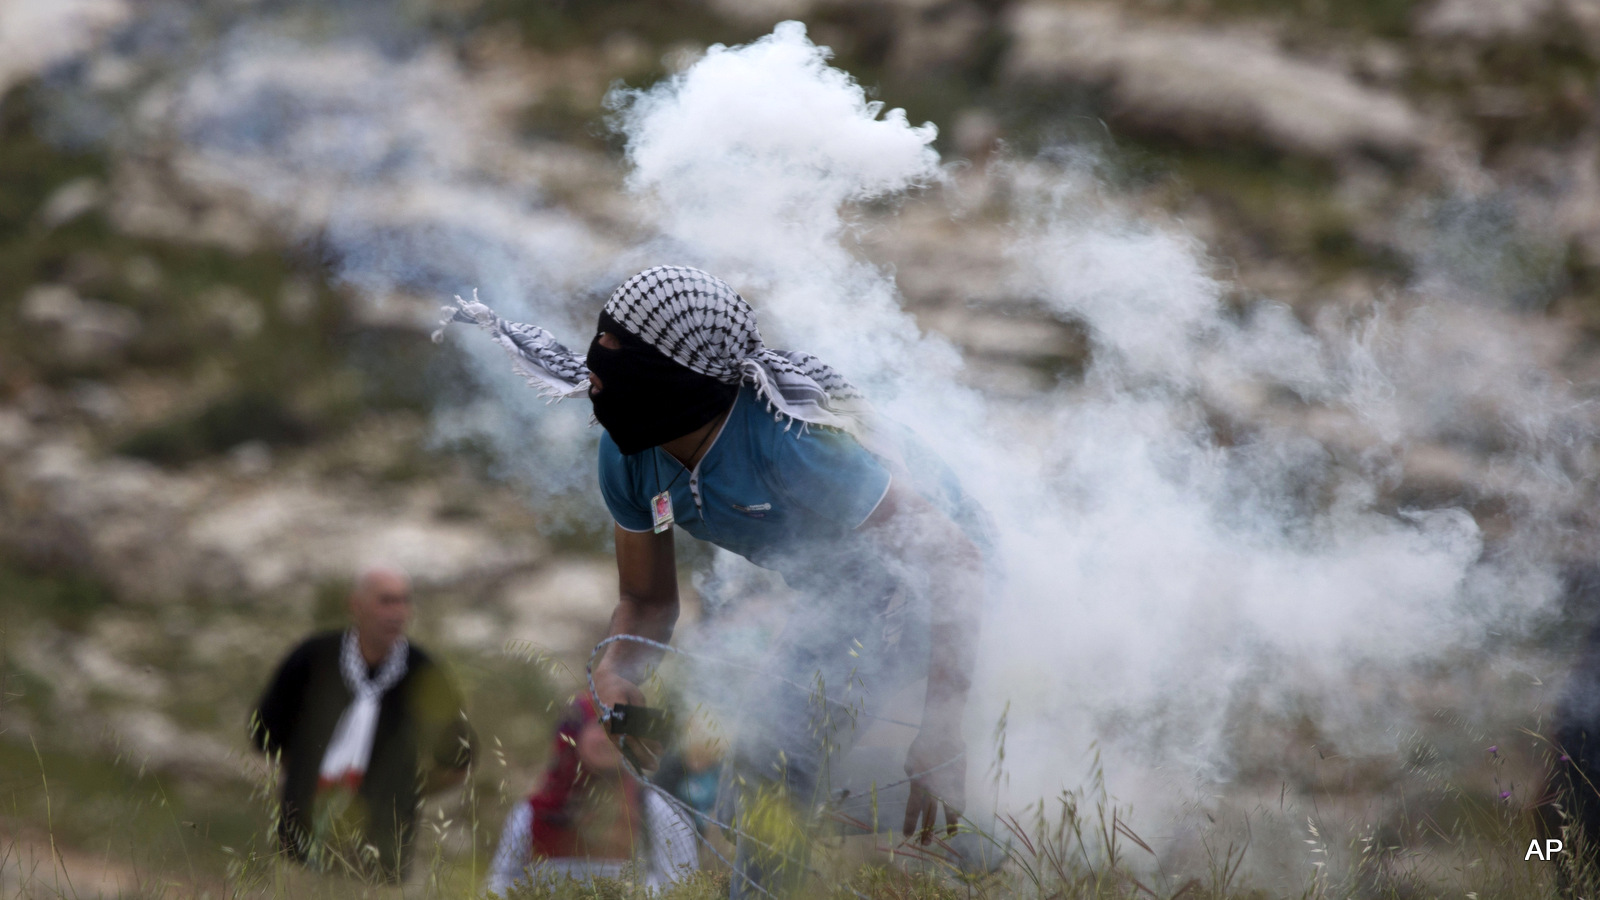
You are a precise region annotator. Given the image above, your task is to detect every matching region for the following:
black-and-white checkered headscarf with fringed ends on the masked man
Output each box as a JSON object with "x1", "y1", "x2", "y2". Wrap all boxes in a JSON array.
[{"x1": 434, "y1": 266, "x2": 867, "y2": 437}]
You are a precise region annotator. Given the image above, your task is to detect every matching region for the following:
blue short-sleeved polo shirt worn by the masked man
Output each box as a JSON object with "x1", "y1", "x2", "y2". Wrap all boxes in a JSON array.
[{"x1": 600, "y1": 386, "x2": 987, "y2": 593}]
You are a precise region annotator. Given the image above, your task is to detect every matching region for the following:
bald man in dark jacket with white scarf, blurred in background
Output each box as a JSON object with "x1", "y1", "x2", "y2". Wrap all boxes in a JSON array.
[{"x1": 250, "y1": 565, "x2": 477, "y2": 881}]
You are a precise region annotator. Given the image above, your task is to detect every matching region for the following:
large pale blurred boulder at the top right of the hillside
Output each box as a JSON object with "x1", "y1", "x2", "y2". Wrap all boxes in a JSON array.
[{"x1": 1005, "y1": 0, "x2": 1424, "y2": 160}]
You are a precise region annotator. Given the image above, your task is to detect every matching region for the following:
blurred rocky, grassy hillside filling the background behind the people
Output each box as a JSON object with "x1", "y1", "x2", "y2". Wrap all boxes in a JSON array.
[{"x1": 0, "y1": 0, "x2": 1600, "y2": 889}]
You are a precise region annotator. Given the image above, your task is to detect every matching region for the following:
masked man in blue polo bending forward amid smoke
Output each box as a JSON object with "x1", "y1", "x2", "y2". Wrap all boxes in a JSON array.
[{"x1": 446, "y1": 266, "x2": 987, "y2": 895}]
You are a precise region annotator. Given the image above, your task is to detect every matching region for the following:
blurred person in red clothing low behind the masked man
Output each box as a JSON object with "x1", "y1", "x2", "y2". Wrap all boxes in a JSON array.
[{"x1": 488, "y1": 693, "x2": 699, "y2": 895}]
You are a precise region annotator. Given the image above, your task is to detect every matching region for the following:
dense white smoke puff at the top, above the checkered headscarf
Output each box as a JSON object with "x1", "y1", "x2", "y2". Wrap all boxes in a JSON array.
[{"x1": 616, "y1": 22, "x2": 939, "y2": 275}]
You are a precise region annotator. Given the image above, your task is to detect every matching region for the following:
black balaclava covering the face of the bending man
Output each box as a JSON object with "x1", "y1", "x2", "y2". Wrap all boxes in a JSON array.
[{"x1": 586, "y1": 312, "x2": 739, "y2": 456}]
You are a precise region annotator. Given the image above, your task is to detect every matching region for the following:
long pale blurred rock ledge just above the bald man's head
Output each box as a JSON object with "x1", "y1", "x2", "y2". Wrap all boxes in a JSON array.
[{"x1": 0, "y1": 420, "x2": 546, "y2": 602}]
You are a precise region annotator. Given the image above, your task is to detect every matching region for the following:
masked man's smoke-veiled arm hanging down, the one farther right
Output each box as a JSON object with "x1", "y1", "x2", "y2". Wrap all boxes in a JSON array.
[{"x1": 861, "y1": 482, "x2": 982, "y2": 842}]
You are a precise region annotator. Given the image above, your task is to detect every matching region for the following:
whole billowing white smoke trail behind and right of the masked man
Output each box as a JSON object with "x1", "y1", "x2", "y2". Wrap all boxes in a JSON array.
[{"x1": 601, "y1": 24, "x2": 1573, "y2": 864}]
